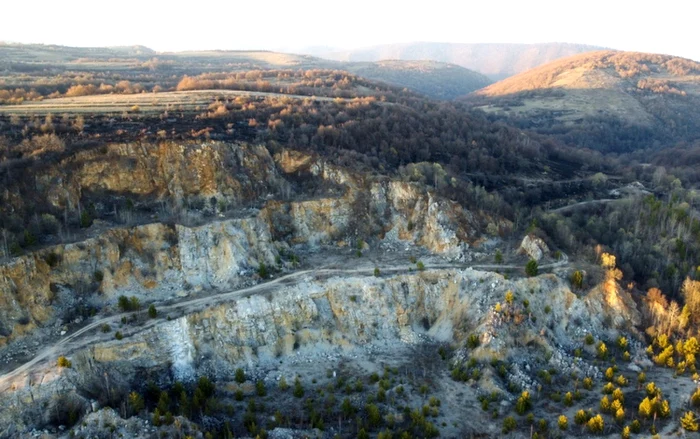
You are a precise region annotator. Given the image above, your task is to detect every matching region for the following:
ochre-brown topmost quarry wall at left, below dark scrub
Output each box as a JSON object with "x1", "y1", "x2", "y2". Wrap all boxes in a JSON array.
[{"x1": 20, "y1": 142, "x2": 283, "y2": 211}]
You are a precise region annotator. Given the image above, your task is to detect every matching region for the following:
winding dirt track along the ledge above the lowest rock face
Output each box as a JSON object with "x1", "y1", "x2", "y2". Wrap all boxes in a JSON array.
[{"x1": 0, "y1": 254, "x2": 569, "y2": 392}]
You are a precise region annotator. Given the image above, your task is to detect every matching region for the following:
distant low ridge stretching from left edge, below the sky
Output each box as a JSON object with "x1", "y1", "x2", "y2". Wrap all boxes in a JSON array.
[{"x1": 0, "y1": 43, "x2": 492, "y2": 100}]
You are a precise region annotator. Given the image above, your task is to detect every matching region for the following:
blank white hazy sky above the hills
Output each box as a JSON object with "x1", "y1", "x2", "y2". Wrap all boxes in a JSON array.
[{"x1": 0, "y1": 0, "x2": 700, "y2": 60}]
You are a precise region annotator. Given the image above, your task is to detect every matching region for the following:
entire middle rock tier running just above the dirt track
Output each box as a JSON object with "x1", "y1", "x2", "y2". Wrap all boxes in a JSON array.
[{"x1": 0, "y1": 177, "x2": 478, "y2": 343}]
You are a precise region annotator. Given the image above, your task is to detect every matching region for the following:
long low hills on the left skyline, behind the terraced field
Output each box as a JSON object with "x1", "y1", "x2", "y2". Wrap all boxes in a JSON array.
[{"x1": 0, "y1": 44, "x2": 491, "y2": 99}]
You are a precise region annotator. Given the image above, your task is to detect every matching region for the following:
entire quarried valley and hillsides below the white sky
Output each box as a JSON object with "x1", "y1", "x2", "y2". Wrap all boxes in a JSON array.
[{"x1": 0, "y1": 44, "x2": 700, "y2": 439}]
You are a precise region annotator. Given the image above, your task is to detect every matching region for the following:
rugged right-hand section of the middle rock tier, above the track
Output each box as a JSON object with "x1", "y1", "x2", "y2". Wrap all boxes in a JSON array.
[{"x1": 261, "y1": 181, "x2": 479, "y2": 259}]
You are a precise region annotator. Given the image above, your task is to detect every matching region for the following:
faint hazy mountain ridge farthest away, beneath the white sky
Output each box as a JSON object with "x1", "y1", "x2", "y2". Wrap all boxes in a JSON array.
[{"x1": 310, "y1": 42, "x2": 603, "y2": 81}]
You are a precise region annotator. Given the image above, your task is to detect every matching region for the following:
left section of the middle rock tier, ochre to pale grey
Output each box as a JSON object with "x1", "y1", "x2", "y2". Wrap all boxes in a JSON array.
[{"x1": 0, "y1": 217, "x2": 277, "y2": 344}]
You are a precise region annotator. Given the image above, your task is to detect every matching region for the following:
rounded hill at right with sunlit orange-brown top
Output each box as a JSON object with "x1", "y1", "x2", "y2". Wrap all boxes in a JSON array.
[{"x1": 467, "y1": 51, "x2": 700, "y2": 152}]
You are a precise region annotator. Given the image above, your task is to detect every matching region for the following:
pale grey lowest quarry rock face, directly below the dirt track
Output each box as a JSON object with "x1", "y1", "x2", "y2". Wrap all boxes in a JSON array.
[{"x1": 0, "y1": 269, "x2": 639, "y2": 431}]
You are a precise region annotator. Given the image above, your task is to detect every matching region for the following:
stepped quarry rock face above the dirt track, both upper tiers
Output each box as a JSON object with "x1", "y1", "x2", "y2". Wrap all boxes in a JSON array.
[{"x1": 0, "y1": 142, "x2": 493, "y2": 346}]
